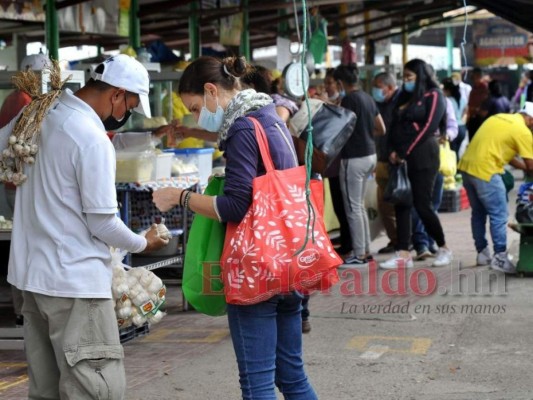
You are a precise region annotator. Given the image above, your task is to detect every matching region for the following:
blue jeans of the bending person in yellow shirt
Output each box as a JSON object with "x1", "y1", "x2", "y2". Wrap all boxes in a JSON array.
[{"x1": 462, "y1": 172, "x2": 508, "y2": 253}]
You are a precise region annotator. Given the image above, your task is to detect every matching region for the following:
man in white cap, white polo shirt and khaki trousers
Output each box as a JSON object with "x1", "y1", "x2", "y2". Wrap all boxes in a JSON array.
[{"x1": 0, "y1": 55, "x2": 168, "y2": 400}]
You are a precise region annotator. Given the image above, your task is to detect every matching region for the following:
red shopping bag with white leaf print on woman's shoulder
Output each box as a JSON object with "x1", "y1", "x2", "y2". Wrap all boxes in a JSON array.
[{"x1": 221, "y1": 118, "x2": 342, "y2": 304}]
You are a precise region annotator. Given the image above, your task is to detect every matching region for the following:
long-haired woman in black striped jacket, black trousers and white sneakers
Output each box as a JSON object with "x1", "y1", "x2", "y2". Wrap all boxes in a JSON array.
[{"x1": 380, "y1": 59, "x2": 453, "y2": 269}]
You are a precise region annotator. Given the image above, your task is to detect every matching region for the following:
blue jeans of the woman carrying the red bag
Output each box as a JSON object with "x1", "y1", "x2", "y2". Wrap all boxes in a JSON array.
[{"x1": 228, "y1": 293, "x2": 318, "y2": 400}]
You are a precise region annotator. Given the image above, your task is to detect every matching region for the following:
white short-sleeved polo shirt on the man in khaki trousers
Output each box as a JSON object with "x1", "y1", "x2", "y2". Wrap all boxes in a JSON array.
[{"x1": 0, "y1": 90, "x2": 117, "y2": 298}]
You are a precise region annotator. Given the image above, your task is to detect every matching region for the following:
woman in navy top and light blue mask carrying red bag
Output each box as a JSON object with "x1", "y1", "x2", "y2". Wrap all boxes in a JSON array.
[{"x1": 150, "y1": 57, "x2": 330, "y2": 400}]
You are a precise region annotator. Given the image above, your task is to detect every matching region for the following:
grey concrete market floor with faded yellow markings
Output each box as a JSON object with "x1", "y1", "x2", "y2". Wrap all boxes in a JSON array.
[{"x1": 0, "y1": 181, "x2": 533, "y2": 400}]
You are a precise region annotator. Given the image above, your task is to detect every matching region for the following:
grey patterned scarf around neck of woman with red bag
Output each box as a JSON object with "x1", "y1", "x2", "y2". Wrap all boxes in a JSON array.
[{"x1": 218, "y1": 89, "x2": 272, "y2": 147}]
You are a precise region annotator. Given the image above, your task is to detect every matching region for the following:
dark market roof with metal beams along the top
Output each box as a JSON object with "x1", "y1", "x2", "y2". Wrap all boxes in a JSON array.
[{"x1": 0, "y1": 0, "x2": 533, "y2": 50}]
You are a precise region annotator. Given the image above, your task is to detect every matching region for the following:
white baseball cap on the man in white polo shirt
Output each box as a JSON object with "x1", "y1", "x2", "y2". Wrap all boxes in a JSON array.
[{"x1": 92, "y1": 54, "x2": 152, "y2": 118}]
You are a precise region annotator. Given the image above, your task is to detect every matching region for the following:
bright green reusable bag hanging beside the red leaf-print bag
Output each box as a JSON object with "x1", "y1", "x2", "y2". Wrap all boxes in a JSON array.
[{"x1": 182, "y1": 176, "x2": 226, "y2": 316}]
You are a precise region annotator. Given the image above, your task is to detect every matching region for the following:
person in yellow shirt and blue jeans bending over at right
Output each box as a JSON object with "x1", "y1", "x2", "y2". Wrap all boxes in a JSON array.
[{"x1": 458, "y1": 102, "x2": 533, "y2": 273}]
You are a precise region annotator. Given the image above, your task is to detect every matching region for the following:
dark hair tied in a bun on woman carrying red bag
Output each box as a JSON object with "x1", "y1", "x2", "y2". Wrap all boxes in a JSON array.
[{"x1": 178, "y1": 57, "x2": 248, "y2": 95}]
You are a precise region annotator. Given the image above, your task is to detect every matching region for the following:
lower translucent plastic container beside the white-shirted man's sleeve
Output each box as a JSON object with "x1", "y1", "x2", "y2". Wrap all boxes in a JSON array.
[{"x1": 115, "y1": 151, "x2": 154, "y2": 182}]
